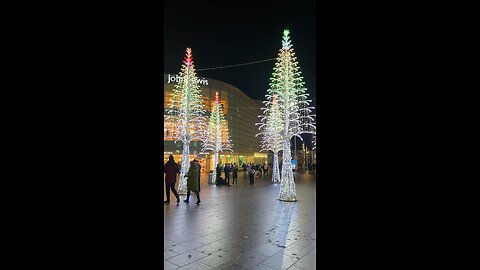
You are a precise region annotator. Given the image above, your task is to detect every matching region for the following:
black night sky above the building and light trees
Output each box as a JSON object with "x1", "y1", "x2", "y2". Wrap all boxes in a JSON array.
[{"x1": 163, "y1": 0, "x2": 316, "y2": 102}]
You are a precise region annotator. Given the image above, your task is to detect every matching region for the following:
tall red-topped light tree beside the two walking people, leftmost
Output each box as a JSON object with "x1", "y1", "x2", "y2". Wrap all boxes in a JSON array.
[{"x1": 166, "y1": 48, "x2": 206, "y2": 195}]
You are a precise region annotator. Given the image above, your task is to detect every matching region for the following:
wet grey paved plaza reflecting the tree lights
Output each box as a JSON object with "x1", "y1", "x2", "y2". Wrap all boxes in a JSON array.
[{"x1": 163, "y1": 171, "x2": 316, "y2": 270}]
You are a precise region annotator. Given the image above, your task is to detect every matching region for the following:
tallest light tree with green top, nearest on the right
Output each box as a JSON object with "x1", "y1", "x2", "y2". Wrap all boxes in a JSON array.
[{"x1": 266, "y1": 30, "x2": 315, "y2": 201}]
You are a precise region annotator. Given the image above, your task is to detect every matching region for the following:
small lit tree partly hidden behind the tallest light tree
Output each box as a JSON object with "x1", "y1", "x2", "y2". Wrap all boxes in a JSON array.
[{"x1": 255, "y1": 94, "x2": 283, "y2": 184}]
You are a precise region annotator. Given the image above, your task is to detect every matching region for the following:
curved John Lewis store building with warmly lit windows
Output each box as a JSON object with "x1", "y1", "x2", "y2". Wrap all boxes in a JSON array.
[{"x1": 163, "y1": 74, "x2": 272, "y2": 172}]
